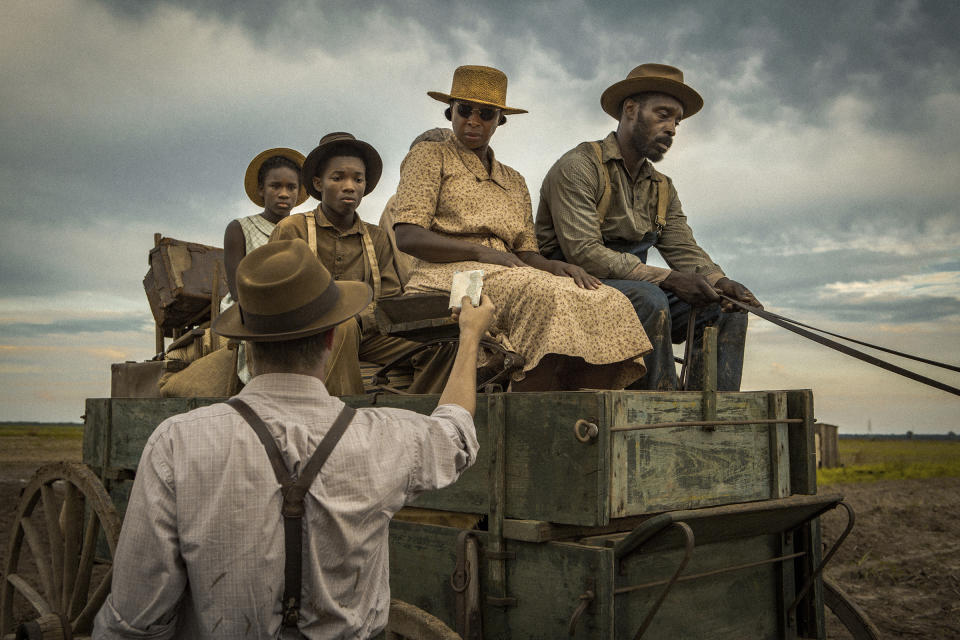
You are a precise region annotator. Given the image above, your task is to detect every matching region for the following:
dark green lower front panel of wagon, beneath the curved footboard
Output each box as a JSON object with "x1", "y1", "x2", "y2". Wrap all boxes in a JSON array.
[{"x1": 615, "y1": 535, "x2": 793, "y2": 640}]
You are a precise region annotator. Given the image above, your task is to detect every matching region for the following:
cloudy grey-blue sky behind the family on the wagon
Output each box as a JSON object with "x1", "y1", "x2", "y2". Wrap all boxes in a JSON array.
[{"x1": 0, "y1": 0, "x2": 960, "y2": 433}]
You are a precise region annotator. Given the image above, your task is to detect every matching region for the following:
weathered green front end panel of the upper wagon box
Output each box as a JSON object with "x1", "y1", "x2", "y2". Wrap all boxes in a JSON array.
[{"x1": 610, "y1": 392, "x2": 772, "y2": 518}]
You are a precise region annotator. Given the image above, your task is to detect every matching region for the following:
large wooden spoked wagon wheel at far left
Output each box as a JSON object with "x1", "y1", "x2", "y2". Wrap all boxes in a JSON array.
[{"x1": 0, "y1": 462, "x2": 120, "y2": 640}]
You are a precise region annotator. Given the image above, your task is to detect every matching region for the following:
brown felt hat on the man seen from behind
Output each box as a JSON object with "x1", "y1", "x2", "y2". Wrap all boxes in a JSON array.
[{"x1": 213, "y1": 238, "x2": 373, "y2": 342}]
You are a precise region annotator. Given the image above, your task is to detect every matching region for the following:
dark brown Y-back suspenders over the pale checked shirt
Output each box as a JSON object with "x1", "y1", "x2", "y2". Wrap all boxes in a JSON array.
[{"x1": 227, "y1": 397, "x2": 357, "y2": 628}]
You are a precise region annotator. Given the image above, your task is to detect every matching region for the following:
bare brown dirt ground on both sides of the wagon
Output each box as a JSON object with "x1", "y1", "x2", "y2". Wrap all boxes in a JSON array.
[{"x1": 0, "y1": 438, "x2": 960, "y2": 640}]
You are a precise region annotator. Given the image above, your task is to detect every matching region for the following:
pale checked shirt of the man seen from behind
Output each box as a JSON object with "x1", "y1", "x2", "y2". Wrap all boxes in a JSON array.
[{"x1": 93, "y1": 374, "x2": 478, "y2": 639}]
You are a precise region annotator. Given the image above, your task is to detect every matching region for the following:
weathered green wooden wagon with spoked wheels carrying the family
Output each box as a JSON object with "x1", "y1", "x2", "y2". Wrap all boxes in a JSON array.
[{"x1": 0, "y1": 378, "x2": 875, "y2": 639}]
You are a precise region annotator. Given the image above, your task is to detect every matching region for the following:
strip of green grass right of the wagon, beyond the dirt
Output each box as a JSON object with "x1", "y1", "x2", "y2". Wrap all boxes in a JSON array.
[{"x1": 817, "y1": 438, "x2": 960, "y2": 484}]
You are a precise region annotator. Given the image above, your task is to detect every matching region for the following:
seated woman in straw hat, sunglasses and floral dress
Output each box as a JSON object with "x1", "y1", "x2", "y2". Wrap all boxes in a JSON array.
[{"x1": 394, "y1": 66, "x2": 650, "y2": 391}]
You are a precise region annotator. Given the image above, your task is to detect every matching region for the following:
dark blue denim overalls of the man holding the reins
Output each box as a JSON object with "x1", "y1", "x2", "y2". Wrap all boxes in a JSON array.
[{"x1": 558, "y1": 231, "x2": 747, "y2": 391}]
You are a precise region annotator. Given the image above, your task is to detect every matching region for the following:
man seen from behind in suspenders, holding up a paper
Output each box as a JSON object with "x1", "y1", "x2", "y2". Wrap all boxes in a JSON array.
[{"x1": 93, "y1": 239, "x2": 493, "y2": 638}]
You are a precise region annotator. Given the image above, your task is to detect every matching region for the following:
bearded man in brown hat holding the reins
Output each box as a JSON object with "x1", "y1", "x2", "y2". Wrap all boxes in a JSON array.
[{"x1": 536, "y1": 64, "x2": 762, "y2": 391}]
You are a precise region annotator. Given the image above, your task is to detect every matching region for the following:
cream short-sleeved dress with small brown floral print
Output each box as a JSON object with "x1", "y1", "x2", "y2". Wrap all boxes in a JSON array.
[{"x1": 394, "y1": 138, "x2": 651, "y2": 386}]
